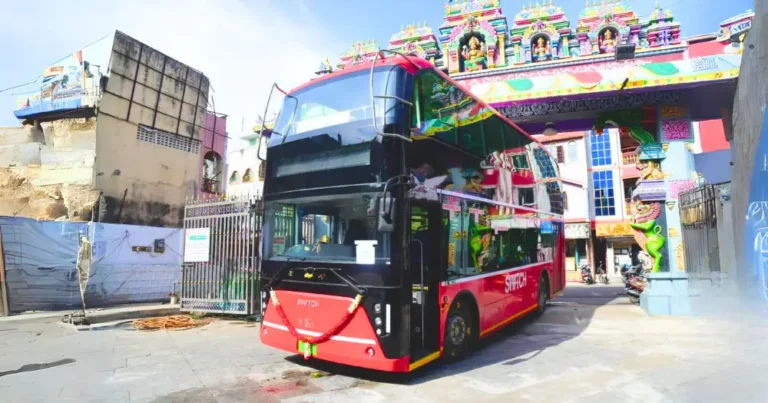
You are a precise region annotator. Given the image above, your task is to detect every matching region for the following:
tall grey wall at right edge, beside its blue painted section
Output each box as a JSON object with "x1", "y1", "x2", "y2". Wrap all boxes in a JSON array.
[{"x1": 726, "y1": 1, "x2": 768, "y2": 291}]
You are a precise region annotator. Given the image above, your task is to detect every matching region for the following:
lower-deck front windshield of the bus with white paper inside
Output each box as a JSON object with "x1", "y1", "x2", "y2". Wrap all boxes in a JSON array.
[{"x1": 263, "y1": 193, "x2": 390, "y2": 264}]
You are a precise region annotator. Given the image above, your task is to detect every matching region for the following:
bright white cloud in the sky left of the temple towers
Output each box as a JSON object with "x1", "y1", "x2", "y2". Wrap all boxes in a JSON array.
[{"x1": 0, "y1": 0, "x2": 344, "y2": 142}]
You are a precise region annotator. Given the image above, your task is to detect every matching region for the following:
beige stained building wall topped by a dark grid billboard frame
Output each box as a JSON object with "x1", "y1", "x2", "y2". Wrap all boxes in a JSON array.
[{"x1": 95, "y1": 32, "x2": 209, "y2": 226}]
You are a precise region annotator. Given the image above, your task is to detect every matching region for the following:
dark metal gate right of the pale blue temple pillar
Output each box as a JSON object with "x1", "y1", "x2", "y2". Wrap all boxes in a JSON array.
[{"x1": 678, "y1": 184, "x2": 730, "y2": 279}]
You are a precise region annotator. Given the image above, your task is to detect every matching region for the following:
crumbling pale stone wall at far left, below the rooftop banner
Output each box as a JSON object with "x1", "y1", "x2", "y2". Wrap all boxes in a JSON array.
[{"x1": 0, "y1": 119, "x2": 98, "y2": 221}]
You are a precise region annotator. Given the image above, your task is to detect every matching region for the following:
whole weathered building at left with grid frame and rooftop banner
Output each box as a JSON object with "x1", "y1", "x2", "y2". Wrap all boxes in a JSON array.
[{"x1": 0, "y1": 32, "x2": 219, "y2": 226}]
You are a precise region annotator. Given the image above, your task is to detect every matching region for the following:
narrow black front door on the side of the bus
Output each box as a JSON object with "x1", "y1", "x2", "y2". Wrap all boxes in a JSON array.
[{"x1": 408, "y1": 201, "x2": 442, "y2": 361}]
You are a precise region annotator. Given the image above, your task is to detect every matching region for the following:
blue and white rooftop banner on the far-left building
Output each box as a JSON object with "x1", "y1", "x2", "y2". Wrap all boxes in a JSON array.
[{"x1": 13, "y1": 50, "x2": 85, "y2": 119}]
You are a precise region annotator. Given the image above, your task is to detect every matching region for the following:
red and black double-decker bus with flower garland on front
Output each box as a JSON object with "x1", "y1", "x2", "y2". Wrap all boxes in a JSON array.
[{"x1": 260, "y1": 52, "x2": 565, "y2": 372}]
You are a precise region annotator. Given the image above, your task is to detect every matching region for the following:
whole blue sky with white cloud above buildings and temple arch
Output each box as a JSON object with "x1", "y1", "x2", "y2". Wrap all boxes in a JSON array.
[{"x1": 0, "y1": 0, "x2": 753, "y2": 136}]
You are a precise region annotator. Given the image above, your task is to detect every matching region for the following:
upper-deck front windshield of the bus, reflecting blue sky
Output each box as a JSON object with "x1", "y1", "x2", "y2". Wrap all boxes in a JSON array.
[{"x1": 270, "y1": 66, "x2": 408, "y2": 146}]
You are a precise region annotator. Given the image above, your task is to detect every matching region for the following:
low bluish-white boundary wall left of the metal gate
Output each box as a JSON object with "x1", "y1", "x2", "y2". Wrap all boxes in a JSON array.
[{"x1": 0, "y1": 217, "x2": 184, "y2": 312}]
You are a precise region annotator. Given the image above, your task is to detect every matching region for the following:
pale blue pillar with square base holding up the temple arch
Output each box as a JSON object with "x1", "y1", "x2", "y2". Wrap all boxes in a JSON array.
[{"x1": 640, "y1": 106, "x2": 697, "y2": 315}]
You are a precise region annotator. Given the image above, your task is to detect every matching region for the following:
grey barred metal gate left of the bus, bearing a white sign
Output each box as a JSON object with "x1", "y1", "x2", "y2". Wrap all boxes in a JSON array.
[{"x1": 181, "y1": 196, "x2": 263, "y2": 315}]
